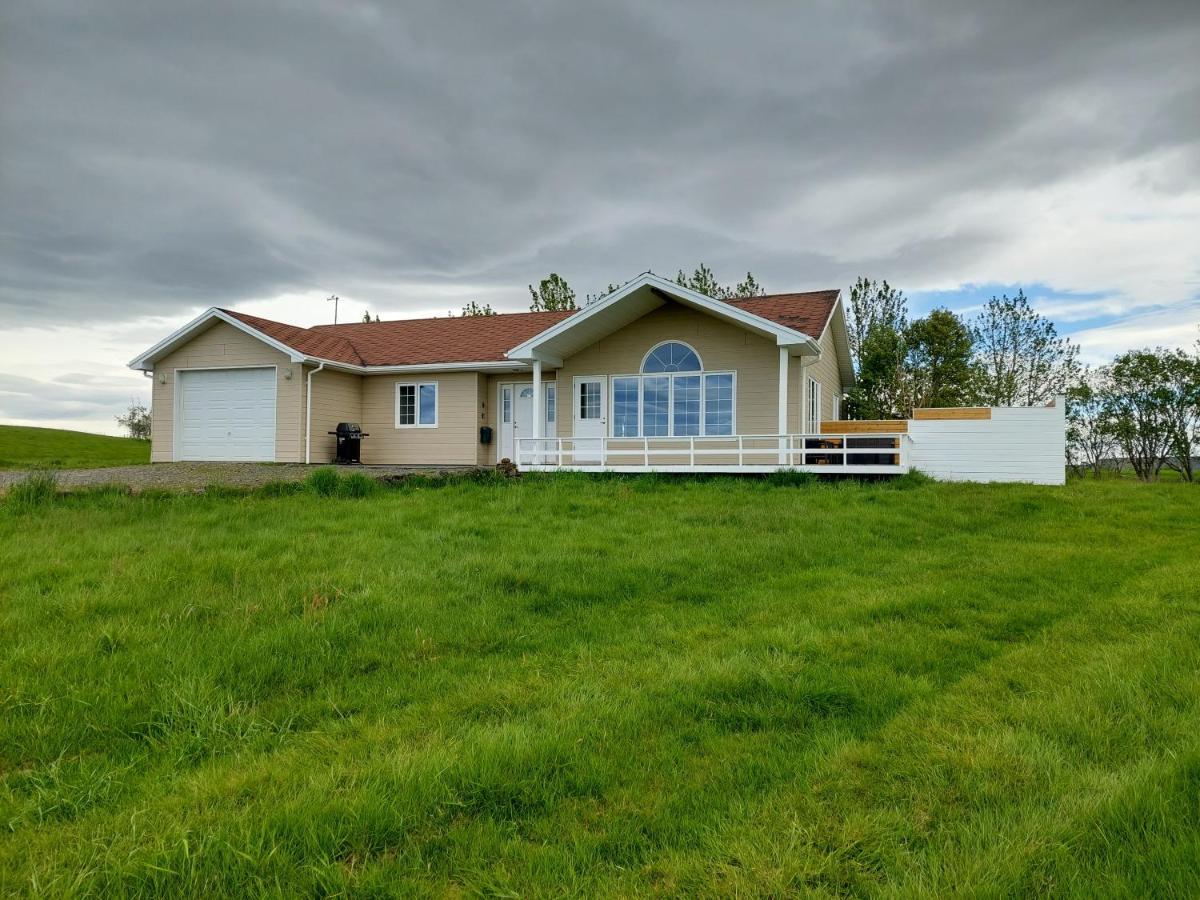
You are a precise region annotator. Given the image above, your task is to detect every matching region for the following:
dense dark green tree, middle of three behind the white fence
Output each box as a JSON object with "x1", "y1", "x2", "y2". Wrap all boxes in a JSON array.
[{"x1": 904, "y1": 308, "x2": 976, "y2": 415}]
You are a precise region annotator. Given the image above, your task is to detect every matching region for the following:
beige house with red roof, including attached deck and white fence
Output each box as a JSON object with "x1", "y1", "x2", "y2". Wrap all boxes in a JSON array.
[{"x1": 130, "y1": 274, "x2": 1064, "y2": 482}]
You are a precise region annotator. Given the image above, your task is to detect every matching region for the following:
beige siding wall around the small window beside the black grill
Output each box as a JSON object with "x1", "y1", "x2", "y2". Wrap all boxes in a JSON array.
[{"x1": 360, "y1": 372, "x2": 480, "y2": 466}]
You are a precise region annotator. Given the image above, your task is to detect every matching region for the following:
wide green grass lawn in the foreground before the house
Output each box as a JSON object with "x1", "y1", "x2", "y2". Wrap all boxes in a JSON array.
[{"x1": 0, "y1": 476, "x2": 1200, "y2": 896}]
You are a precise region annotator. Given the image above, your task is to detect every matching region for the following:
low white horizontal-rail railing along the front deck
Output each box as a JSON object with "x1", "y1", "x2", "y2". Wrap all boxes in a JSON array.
[{"x1": 514, "y1": 432, "x2": 910, "y2": 474}]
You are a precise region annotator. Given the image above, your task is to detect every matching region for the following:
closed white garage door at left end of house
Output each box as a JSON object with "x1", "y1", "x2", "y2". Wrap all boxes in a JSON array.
[{"x1": 176, "y1": 368, "x2": 275, "y2": 462}]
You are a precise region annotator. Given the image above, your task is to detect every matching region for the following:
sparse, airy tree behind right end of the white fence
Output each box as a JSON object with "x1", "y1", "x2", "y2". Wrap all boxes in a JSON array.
[{"x1": 971, "y1": 290, "x2": 1079, "y2": 407}]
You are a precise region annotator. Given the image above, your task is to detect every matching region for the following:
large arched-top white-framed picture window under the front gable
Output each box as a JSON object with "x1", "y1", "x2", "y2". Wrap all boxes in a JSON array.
[{"x1": 612, "y1": 341, "x2": 736, "y2": 438}]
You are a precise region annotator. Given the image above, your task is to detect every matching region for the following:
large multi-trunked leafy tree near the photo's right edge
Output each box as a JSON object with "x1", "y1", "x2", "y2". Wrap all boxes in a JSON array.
[{"x1": 1104, "y1": 348, "x2": 1183, "y2": 481}]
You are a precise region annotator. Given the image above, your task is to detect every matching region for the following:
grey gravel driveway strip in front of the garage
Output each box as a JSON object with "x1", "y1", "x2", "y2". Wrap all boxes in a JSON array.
[{"x1": 0, "y1": 462, "x2": 473, "y2": 493}]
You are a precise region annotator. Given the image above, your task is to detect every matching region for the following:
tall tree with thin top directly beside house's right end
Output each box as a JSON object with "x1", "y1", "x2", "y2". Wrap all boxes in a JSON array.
[{"x1": 846, "y1": 278, "x2": 912, "y2": 419}]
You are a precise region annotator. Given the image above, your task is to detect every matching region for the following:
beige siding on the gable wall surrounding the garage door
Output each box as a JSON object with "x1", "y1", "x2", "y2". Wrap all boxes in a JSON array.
[{"x1": 150, "y1": 322, "x2": 304, "y2": 462}]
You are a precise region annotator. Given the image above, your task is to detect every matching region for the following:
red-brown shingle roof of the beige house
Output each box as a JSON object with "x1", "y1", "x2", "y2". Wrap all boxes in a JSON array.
[{"x1": 223, "y1": 290, "x2": 838, "y2": 366}]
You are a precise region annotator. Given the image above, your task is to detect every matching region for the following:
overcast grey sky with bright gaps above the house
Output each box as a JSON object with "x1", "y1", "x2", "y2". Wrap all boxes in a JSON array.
[{"x1": 0, "y1": 0, "x2": 1200, "y2": 432}]
